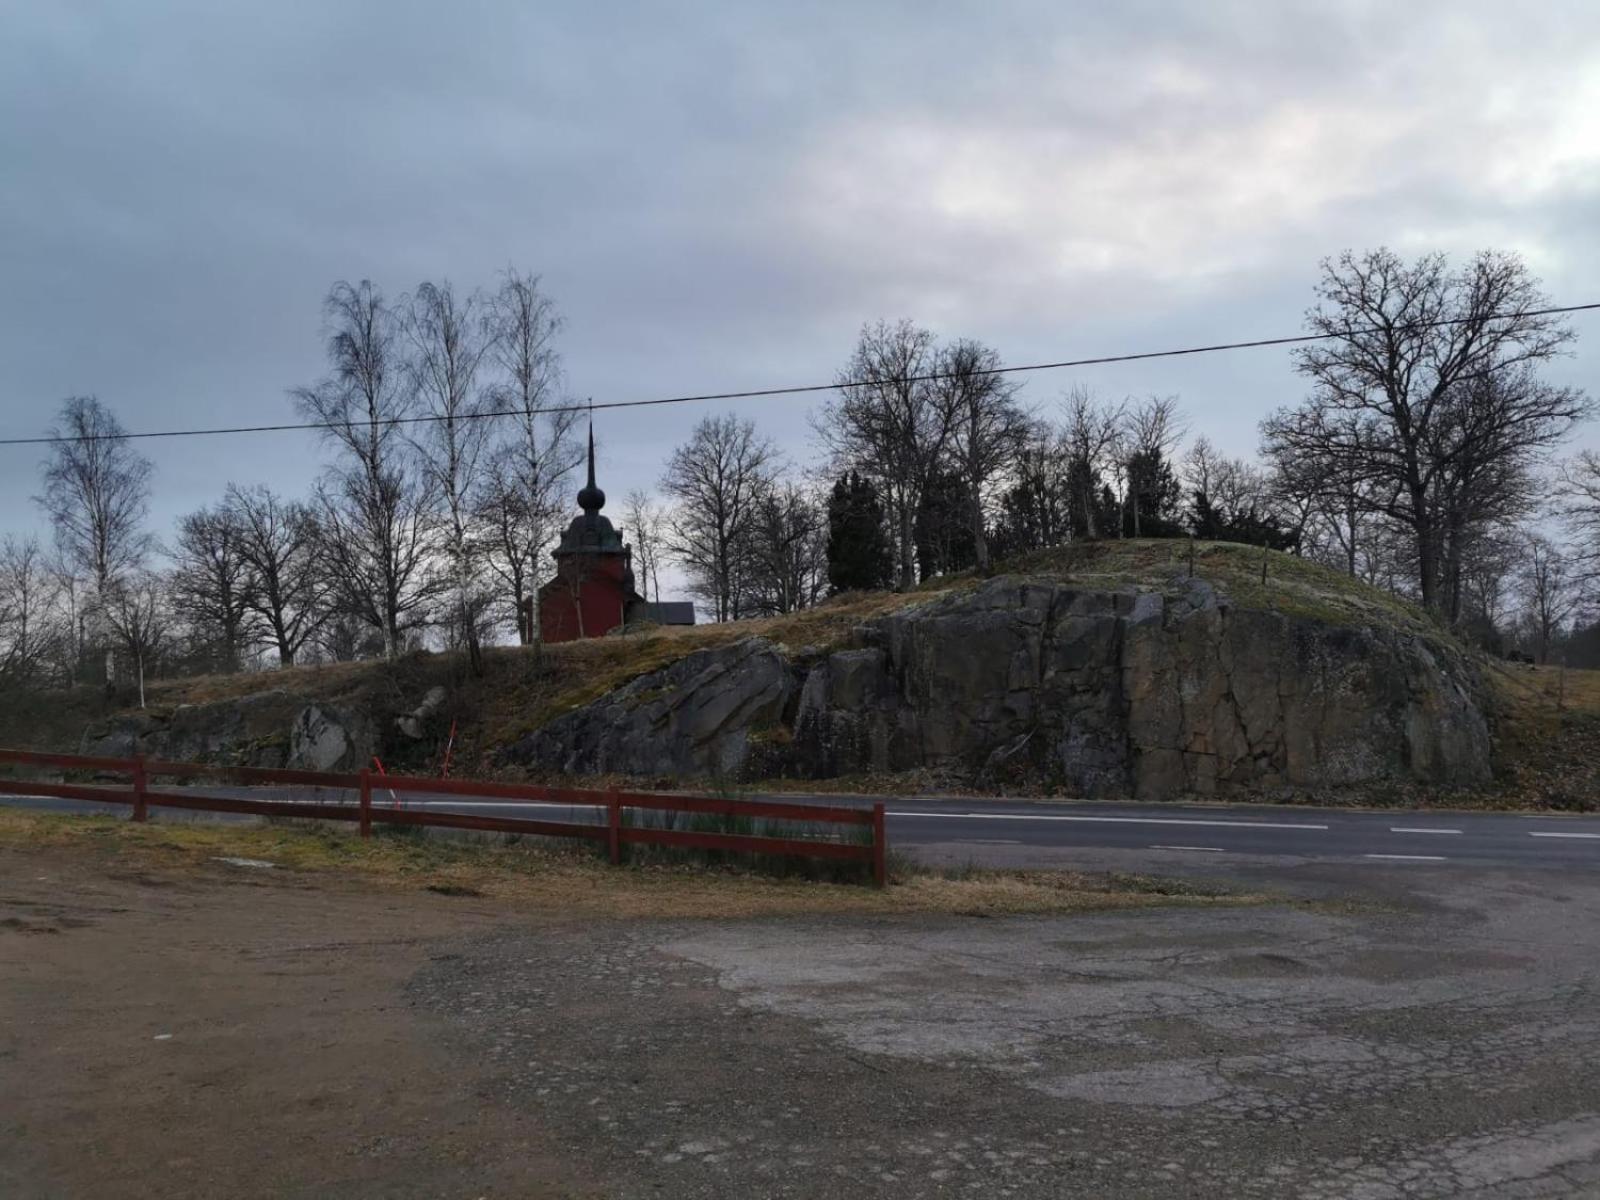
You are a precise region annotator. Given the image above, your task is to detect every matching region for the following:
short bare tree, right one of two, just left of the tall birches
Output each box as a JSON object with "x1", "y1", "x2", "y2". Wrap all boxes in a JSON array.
[{"x1": 224, "y1": 485, "x2": 331, "y2": 667}]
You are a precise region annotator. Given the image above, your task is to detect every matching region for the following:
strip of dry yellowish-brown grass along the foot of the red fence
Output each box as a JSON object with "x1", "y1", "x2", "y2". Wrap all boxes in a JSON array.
[{"x1": 0, "y1": 810, "x2": 1264, "y2": 918}]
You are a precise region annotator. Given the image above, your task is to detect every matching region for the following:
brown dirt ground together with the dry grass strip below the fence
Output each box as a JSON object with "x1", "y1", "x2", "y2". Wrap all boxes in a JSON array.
[{"x1": 0, "y1": 810, "x2": 1250, "y2": 1200}]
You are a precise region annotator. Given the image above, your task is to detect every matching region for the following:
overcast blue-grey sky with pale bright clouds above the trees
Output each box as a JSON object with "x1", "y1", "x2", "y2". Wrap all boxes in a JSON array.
[{"x1": 0, "y1": 0, "x2": 1600, "y2": 553}]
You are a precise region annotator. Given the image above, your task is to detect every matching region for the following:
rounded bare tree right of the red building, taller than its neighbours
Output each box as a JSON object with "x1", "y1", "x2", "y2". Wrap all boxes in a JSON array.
[{"x1": 661, "y1": 413, "x2": 778, "y2": 621}]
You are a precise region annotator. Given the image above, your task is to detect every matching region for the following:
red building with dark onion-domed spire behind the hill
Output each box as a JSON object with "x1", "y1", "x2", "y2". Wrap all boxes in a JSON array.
[{"x1": 539, "y1": 427, "x2": 694, "y2": 642}]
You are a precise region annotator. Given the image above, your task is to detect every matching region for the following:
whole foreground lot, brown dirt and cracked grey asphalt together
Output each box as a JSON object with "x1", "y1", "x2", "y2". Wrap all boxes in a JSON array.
[{"x1": 9, "y1": 834, "x2": 1600, "y2": 1200}]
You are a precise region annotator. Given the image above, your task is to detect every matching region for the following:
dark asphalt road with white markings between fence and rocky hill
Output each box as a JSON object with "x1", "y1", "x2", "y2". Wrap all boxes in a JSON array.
[{"x1": 0, "y1": 789, "x2": 1600, "y2": 869}]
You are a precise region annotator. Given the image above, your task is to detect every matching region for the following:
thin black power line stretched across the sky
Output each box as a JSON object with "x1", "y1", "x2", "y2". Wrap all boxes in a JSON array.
[{"x1": 0, "y1": 302, "x2": 1600, "y2": 446}]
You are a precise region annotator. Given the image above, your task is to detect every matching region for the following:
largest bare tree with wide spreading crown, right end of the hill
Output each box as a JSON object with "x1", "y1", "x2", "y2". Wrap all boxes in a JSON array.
[{"x1": 1262, "y1": 250, "x2": 1589, "y2": 616}]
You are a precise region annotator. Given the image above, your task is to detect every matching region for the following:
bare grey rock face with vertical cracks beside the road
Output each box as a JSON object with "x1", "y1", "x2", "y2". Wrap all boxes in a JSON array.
[{"x1": 507, "y1": 578, "x2": 1490, "y2": 798}]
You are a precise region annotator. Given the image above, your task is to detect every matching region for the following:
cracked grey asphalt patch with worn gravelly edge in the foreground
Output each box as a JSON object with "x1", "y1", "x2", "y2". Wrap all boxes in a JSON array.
[{"x1": 406, "y1": 869, "x2": 1600, "y2": 1200}]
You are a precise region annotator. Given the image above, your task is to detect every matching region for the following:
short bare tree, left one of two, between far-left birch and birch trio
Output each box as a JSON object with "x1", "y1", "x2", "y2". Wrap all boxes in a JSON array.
[{"x1": 171, "y1": 506, "x2": 256, "y2": 674}]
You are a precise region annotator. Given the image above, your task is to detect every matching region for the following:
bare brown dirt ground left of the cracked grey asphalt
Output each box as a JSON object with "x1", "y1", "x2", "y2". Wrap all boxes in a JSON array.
[{"x1": 0, "y1": 850, "x2": 602, "y2": 1200}]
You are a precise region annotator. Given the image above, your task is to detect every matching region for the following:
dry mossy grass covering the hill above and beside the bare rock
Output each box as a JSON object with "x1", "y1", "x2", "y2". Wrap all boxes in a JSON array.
[{"x1": 0, "y1": 541, "x2": 1600, "y2": 808}]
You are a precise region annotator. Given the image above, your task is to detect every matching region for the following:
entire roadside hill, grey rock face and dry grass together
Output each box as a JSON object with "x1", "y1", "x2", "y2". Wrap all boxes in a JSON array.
[{"x1": 0, "y1": 541, "x2": 1600, "y2": 806}]
